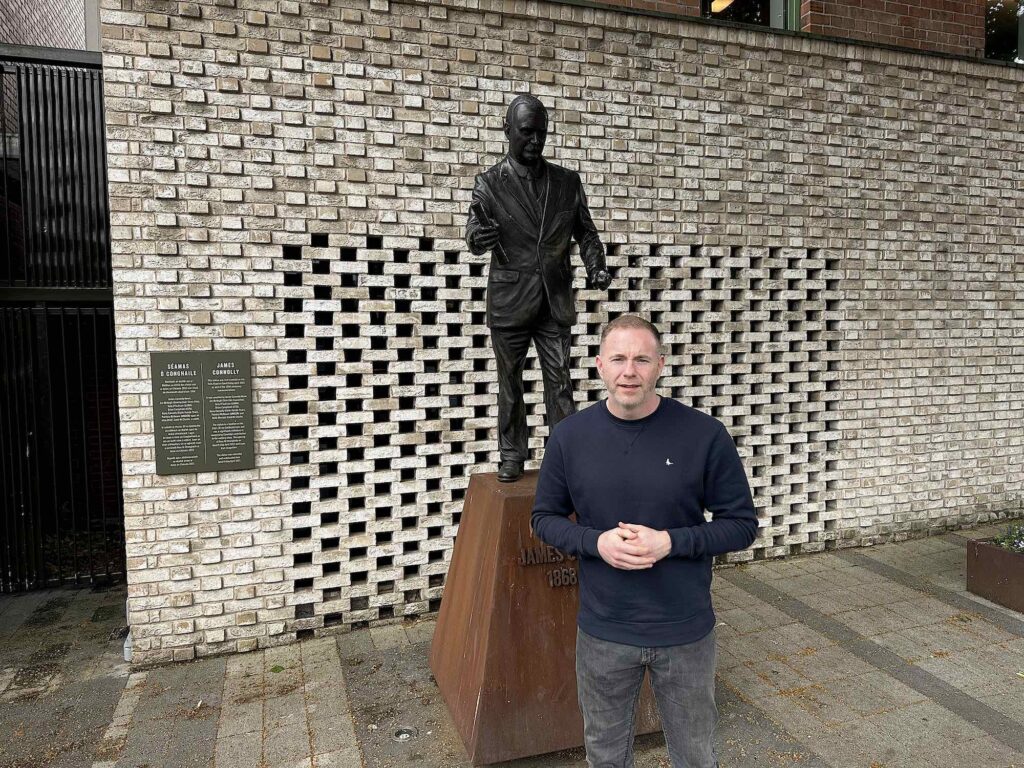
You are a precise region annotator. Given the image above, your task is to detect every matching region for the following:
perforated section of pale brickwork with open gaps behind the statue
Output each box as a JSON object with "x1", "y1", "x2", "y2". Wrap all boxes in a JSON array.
[{"x1": 274, "y1": 236, "x2": 839, "y2": 636}]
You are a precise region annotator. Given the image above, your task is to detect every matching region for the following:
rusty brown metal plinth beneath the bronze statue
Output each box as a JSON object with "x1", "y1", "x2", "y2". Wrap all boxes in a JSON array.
[{"x1": 430, "y1": 472, "x2": 659, "y2": 765}]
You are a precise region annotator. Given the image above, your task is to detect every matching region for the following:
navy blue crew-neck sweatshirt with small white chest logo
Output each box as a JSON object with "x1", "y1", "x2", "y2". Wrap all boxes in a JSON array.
[{"x1": 530, "y1": 397, "x2": 758, "y2": 647}]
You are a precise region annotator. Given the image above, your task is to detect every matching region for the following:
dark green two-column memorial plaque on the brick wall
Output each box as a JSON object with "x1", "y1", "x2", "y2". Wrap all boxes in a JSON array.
[{"x1": 150, "y1": 351, "x2": 256, "y2": 475}]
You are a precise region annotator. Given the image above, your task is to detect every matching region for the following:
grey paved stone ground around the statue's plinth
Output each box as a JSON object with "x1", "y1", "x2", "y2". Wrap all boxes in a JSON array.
[{"x1": 0, "y1": 528, "x2": 1024, "y2": 768}]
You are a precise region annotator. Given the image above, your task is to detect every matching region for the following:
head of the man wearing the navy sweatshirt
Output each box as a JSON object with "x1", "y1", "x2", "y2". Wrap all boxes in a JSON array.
[{"x1": 597, "y1": 328, "x2": 665, "y2": 419}]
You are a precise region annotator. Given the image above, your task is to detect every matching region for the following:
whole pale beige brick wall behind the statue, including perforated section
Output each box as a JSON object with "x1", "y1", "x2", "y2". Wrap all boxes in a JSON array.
[{"x1": 102, "y1": 0, "x2": 1024, "y2": 662}]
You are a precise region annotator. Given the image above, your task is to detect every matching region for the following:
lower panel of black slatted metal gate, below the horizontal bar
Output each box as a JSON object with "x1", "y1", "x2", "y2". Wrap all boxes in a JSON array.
[{"x1": 0, "y1": 306, "x2": 124, "y2": 591}]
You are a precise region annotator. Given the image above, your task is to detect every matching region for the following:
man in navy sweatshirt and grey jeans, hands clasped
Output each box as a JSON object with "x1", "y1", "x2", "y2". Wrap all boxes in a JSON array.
[{"x1": 531, "y1": 315, "x2": 758, "y2": 768}]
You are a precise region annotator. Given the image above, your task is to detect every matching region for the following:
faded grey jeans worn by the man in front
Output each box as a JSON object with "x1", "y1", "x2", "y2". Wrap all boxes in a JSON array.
[{"x1": 577, "y1": 630, "x2": 718, "y2": 768}]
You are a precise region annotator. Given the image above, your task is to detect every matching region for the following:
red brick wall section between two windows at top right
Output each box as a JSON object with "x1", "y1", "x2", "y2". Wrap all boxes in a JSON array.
[{"x1": 801, "y1": 0, "x2": 985, "y2": 56}]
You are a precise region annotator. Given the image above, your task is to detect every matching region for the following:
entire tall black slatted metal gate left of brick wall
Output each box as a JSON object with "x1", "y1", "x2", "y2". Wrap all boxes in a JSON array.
[{"x1": 0, "y1": 46, "x2": 124, "y2": 592}]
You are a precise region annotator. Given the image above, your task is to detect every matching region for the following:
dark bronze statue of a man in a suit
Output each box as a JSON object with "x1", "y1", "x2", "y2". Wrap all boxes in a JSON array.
[{"x1": 466, "y1": 94, "x2": 611, "y2": 482}]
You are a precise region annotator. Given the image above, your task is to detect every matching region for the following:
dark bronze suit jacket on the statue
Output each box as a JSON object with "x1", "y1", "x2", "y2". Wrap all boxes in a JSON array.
[{"x1": 466, "y1": 158, "x2": 605, "y2": 329}]
